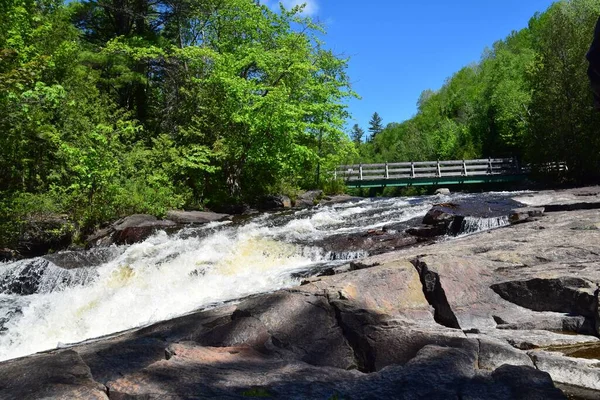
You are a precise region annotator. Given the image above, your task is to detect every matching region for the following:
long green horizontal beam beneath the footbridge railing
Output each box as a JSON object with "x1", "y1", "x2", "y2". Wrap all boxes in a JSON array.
[{"x1": 346, "y1": 174, "x2": 527, "y2": 188}]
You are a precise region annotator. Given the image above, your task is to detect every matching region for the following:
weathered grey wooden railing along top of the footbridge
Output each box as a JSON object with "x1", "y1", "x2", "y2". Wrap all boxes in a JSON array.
[{"x1": 335, "y1": 158, "x2": 523, "y2": 181}]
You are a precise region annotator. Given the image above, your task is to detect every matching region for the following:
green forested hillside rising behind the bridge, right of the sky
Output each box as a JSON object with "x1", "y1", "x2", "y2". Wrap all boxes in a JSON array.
[{"x1": 351, "y1": 0, "x2": 600, "y2": 182}]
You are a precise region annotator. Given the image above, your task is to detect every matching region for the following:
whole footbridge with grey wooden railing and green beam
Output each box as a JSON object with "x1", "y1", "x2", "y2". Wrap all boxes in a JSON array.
[{"x1": 334, "y1": 158, "x2": 567, "y2": 188}]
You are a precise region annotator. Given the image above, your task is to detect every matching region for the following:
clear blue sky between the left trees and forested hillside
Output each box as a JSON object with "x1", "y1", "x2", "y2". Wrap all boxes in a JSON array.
[{"x1": 271, "y1": 0, "x2": 553, "y2": 130}]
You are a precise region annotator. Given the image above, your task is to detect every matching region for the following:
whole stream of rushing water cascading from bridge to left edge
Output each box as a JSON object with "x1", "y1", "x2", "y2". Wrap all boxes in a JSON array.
[{"x1": 0, "y1": 193, "x2": 514, "y2": 360}]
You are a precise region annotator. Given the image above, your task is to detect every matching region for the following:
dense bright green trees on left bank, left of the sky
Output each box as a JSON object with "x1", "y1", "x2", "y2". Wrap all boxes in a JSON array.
[{"x1": 0, "y1": 0, "x2": 355, "y2": 245}]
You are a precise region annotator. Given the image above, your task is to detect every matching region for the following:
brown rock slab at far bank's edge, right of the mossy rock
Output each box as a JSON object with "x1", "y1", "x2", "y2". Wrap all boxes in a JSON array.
[{"x1": 87, "y1": 214, "x2": 177, "y2": 246}]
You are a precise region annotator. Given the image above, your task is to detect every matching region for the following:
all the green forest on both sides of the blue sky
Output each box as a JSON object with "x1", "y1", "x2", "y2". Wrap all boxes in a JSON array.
[{"x1": 0, "y1": 0, "x2": 600, "y2": 247}]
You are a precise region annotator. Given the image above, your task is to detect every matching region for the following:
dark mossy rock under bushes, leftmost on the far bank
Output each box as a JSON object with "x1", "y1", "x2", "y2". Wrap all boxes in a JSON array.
[{"x1": 16, "y1": 215, "x2": 75, "y2": 258}]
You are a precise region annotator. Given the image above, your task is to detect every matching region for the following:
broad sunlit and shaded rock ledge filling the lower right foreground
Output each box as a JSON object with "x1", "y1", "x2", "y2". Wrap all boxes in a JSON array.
[{"x1": 0, "y1": 188, "x2": 600, "y2": 400}]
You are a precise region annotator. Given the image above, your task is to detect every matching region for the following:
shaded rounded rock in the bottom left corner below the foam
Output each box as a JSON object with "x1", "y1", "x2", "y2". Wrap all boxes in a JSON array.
[{"x1": 0, "y1": 350, "x2": 108, "y2": 400}]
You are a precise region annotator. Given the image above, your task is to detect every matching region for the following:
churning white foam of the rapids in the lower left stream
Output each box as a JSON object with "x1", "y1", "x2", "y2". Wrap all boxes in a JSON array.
[{"x1": 0, "y1": 224, "x2": 325, "y2": 360}]
